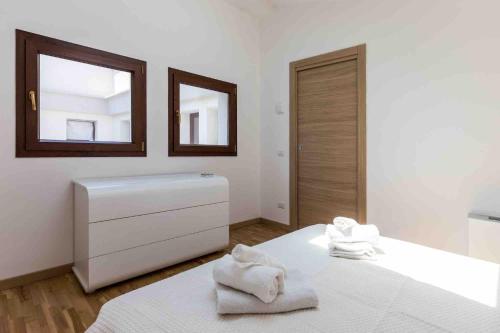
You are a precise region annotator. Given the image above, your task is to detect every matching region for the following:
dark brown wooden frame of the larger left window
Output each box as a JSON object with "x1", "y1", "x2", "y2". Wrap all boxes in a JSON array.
[{"x1": 16, "y1": 30, "x2": 147, "y2": 157}]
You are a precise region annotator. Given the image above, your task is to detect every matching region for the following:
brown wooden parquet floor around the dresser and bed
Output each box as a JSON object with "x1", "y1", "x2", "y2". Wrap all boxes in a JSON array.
[{"x1": 0, "y1": 223, "x2": 286, "y2": 332}]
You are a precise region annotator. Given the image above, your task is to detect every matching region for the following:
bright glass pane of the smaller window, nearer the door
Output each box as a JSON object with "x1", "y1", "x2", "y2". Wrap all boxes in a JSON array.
[{"x1": 178, "y1": 84, "x2": 229, "y2": 146}]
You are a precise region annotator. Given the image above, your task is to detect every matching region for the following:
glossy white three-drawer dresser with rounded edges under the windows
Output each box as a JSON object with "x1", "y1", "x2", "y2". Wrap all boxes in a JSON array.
[{"x1": 73, "y1": 174, "x2": 229, "y2": 292}]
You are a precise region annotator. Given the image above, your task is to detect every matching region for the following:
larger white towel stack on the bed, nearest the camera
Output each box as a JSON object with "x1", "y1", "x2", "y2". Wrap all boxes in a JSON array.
[{"x1": 213, "y1": 244, "x2": 318, "y2": 314}]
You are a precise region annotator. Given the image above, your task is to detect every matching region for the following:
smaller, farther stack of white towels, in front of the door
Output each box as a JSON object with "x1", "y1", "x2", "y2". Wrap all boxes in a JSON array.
[{"x1": 325, "y1": 217, "x2": 380, "y2": 260}]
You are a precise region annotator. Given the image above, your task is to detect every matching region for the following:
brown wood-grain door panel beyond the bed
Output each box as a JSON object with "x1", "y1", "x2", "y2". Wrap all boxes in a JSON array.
[{"x1": 294, "y1": 48, "x2": 365, "y2": 228}]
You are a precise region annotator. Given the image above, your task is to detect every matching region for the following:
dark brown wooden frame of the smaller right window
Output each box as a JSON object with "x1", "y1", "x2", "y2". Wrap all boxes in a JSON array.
[{"x1": 168, "y1": 67, "x2": 238, "y2": 156}]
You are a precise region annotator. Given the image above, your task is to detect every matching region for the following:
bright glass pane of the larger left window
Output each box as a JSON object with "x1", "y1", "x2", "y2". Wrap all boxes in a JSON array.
[{"x1": 39, "y1": 54, "x2": 132, "y2": 142}]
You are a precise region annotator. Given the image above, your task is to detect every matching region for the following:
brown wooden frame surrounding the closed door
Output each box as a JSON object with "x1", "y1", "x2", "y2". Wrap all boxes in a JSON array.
[{"x1": 290, "y1": 44, "x2": 366, "y2": 230}]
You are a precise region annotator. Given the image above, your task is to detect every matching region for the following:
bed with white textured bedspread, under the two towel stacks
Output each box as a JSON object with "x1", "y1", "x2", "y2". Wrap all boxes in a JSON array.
[{"x1": 88, "y1": 225, "x2": 500, "y2": 333}]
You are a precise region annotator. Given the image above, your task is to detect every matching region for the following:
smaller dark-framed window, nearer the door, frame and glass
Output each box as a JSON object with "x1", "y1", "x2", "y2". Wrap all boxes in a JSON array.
[{"x1": 169, "y1": 68, "x2": 237, "y2": 156}]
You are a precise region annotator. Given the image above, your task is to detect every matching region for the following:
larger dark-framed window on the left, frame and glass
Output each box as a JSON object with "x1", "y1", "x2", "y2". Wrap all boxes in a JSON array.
[{"x1": 16, "y1": 30, "x2": 146, "y2": 157}]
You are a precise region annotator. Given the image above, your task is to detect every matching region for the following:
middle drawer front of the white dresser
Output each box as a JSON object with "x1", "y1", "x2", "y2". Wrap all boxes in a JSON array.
[{"x1": 89, "y1": 202, "x2": 229, "y2": 258}]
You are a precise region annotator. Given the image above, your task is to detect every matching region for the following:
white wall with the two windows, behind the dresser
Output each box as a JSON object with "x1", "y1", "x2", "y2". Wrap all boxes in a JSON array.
[{"x1": 0, "y1": 0, "x2": 260, "y2": 279}]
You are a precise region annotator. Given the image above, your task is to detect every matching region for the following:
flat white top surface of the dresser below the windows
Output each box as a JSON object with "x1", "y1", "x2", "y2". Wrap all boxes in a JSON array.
[{"x1": 73, "y1": 173, "x2": 227, "y2": 189}]
